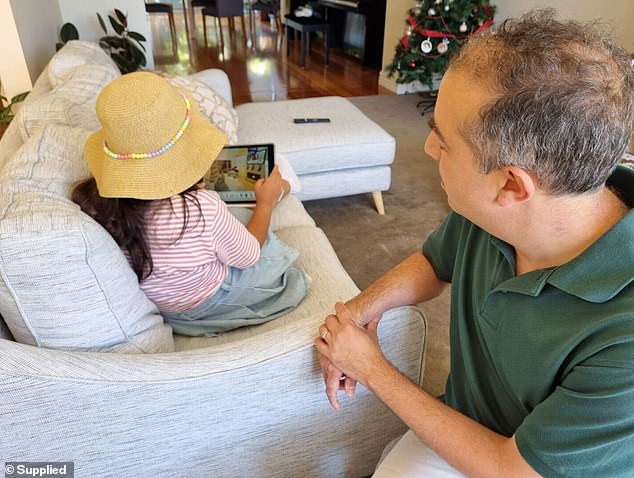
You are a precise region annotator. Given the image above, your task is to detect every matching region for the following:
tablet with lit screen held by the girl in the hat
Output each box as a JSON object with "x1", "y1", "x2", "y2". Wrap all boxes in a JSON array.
[{"x1": 203, "y1": 143, "x2": 275, "y2": 204}]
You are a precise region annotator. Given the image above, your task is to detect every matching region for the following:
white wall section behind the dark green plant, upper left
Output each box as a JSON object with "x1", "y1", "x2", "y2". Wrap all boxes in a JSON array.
[{"x1": 57, "y1": 0, "x2": 154, "y2": 69}]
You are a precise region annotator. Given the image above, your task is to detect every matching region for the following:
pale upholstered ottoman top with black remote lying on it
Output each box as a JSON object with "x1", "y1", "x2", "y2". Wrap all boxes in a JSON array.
[{"x1": 236, "y1": 96, "x2": 396, "y2": 176}]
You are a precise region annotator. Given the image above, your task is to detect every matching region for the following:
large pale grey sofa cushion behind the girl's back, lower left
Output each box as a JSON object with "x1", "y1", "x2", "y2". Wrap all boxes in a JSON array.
[{"x1": 0, "y1": 192, "x2": 173, "y2": 353}]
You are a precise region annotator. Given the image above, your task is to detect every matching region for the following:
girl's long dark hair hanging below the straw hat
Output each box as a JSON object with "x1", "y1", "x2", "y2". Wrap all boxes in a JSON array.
[{"x1": 71, "y1": 178, "x2": 204, "y2": 281}]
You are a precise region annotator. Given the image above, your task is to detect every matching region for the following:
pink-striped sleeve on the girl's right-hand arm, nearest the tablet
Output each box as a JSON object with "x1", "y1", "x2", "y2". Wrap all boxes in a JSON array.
[{"x1": 198, "y1": 191, "x2": 260, "y2": 269}]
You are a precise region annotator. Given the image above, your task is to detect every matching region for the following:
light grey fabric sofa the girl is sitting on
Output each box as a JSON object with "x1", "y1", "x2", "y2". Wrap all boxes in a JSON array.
[{"x1": 0, "y1": 42, "x2": 426, "y2": 478}]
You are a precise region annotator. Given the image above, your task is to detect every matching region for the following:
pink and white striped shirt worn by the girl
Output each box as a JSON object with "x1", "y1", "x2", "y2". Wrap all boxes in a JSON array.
[{"x1": 140, "y1": 189, "x2": 260, "y2": 312}]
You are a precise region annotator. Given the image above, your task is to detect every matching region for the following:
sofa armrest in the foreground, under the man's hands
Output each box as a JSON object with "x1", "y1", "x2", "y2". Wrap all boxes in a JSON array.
[{"x1": 0, "y1": 307, "x2": 425, "y2": 478}]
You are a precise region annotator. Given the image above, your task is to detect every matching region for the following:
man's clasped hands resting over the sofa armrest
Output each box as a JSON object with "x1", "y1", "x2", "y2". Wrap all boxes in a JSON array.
[{"x1": 315, "y1": 302, "x2": 386, "y2": 410}]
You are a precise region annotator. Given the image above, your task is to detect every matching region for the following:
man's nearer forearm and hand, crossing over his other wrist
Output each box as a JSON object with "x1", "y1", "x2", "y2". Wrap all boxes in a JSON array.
[{"x1": 315, "y1": 303, "x2": 539, "y2": 477}]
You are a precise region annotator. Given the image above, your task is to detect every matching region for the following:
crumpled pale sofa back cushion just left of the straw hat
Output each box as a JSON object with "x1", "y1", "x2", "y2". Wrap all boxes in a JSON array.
[{"x1": 14, "y1": 65, "x2": 118, "y2": 140}]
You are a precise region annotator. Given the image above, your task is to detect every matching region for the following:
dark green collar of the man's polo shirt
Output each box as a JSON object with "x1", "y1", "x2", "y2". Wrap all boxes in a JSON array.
[{"x1": 492, "y1": 167, "x2": 634, "y2": 303}]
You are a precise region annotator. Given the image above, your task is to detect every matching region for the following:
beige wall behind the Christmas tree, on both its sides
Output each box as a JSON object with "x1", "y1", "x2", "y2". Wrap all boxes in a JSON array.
[{"x1": 379, "y1": 0, "x2": 634, "y2": 91}]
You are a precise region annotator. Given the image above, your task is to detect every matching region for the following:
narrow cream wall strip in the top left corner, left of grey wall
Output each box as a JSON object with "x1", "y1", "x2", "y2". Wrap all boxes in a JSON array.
[{"x1": 0, "y1": 0, "x2": 32, "y2": 99}]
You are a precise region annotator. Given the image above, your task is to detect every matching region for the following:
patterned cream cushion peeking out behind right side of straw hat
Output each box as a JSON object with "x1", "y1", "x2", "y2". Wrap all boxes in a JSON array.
[{"x1": 161, "y1": 73, "x2": 238, "y2": 144}]
